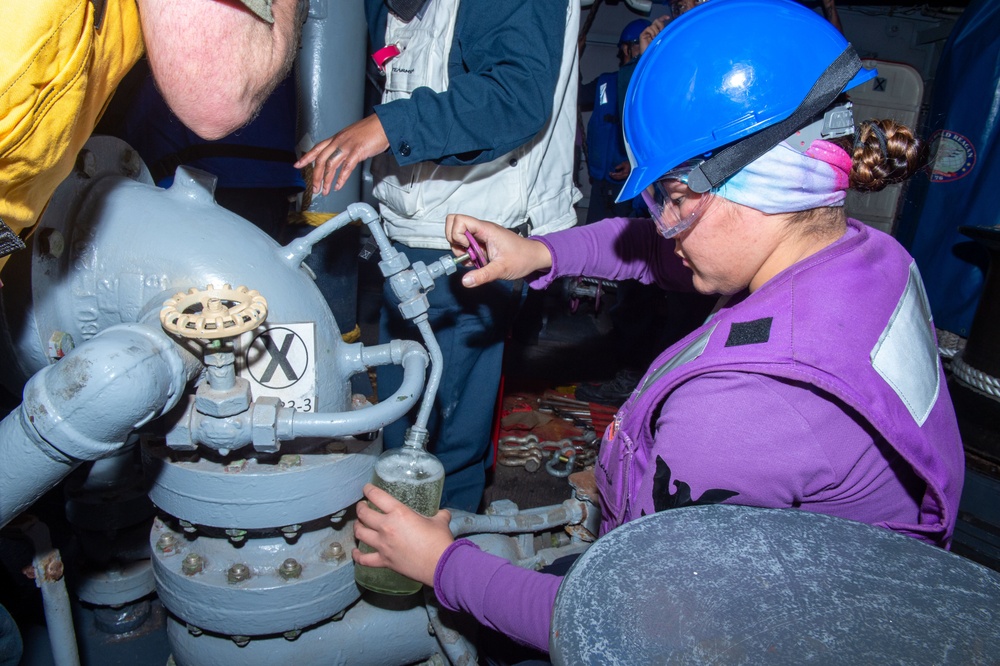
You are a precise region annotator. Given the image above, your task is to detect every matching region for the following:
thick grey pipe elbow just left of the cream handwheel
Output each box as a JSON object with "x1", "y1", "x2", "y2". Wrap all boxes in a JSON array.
[{"x1": 0, "y1": 324, "x2": 203, "y2": 527}]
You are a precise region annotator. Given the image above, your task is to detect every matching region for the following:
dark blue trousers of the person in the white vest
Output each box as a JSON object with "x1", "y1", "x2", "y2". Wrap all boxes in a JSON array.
[{"x1": 376, "y1": 244, "x2": 516, "y2": 511}]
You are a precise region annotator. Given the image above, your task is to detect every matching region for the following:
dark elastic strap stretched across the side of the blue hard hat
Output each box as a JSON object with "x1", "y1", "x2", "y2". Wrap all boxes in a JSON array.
[{"x1": 687, "y1": 44, "x2": 861, "y2": 192}]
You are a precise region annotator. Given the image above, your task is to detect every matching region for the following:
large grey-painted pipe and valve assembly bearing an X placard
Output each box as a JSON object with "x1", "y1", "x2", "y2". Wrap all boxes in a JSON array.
[{"x1": 0, "y1": 137, "x2": 593, "y2": 666}]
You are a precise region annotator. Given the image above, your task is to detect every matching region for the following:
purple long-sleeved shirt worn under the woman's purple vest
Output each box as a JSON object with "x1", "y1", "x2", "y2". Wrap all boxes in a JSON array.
[{"x1": 435, "y1": 218, "x2": 961, "y2": 651}]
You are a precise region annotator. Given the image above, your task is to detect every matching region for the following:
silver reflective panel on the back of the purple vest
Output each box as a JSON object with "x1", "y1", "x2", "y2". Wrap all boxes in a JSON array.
[{"x1": 871, "y1": 262, "x2": 941, "y2": 426}]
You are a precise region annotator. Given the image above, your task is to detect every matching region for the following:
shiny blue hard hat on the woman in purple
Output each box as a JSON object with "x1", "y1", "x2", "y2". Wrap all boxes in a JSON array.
[{"x1": 618, "y1": 0, "x2": 876, "y2": 201}]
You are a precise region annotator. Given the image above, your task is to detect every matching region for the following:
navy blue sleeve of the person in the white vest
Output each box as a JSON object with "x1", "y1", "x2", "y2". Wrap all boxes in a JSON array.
[{"x1": 375, "y1": 0, "x2": 568, "y2": 166}]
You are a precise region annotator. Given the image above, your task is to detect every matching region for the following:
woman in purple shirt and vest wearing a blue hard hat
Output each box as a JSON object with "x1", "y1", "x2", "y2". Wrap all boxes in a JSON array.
[{"x1": 354, "y1": 0, "x2": 964, "y2": 650}]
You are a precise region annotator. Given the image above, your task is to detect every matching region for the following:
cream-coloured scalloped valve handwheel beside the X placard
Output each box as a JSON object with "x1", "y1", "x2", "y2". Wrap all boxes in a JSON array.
[{"x1": 160, "y1": 284, "x2": 267, "y2": 340}]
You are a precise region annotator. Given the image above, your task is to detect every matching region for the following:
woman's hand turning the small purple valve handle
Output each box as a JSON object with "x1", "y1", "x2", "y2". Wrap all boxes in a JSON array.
[{"x1": 445, "y1": 213, "x2": 552, "y2": 287}]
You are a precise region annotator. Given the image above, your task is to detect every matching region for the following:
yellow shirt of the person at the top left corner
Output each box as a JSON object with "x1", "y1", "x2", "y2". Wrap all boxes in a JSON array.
[{"x1": 0, "y1": 0, "x2": 143, "y2": 269}]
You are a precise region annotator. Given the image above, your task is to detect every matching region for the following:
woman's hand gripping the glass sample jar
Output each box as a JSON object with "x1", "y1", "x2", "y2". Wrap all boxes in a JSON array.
[{"x1": 351, "y1": 483, "x2": 455, "y2": 586}]
